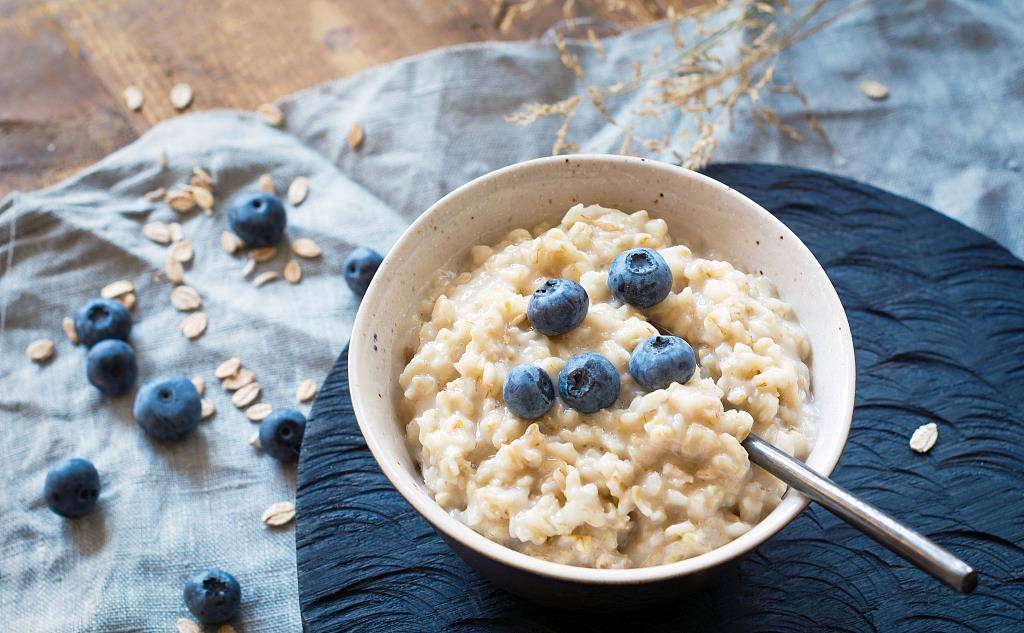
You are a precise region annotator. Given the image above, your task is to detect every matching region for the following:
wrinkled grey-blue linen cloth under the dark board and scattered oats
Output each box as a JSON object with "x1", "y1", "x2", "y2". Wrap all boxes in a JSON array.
[{"x1": 0, "y1": 0, "x2": 1024, "y2": 632}]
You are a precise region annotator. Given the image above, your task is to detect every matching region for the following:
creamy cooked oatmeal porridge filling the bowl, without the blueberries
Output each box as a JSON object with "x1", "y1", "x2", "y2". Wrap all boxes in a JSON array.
[{"x1": 400, "y1": 205, "x2": 815, "y2": 567}]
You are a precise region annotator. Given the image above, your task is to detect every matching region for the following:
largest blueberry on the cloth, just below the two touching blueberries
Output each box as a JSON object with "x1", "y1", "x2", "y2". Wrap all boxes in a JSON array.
[{"x1": 132, "y1": 376, "x2": 202, "y2": 439}]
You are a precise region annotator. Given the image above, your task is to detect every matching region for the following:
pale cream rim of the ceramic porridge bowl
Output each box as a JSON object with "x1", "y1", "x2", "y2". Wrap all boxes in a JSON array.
[{"x1": 348, "y1": 154, "x2": 856, "y2": 585}]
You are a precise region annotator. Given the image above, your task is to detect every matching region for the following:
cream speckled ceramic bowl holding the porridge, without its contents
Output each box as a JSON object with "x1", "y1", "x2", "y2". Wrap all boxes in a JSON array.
[{"x1": 348, "y1": 155, "x2": 855, "y2": 609}]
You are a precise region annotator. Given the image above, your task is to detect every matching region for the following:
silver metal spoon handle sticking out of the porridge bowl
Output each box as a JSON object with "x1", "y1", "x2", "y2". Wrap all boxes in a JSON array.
[{"x1": 743, "y1": 434, "x2": 978, "y2": 593}]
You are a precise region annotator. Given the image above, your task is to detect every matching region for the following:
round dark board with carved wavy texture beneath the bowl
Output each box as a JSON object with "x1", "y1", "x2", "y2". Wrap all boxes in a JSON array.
[{"x1": 296, "y1": 165, "x2": 1024, "y2": 633}]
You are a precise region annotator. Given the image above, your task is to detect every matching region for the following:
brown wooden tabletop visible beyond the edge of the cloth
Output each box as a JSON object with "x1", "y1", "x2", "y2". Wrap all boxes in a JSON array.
[{"x1": 0, "y1": 0, "x2": 658, "y2": 196}]
